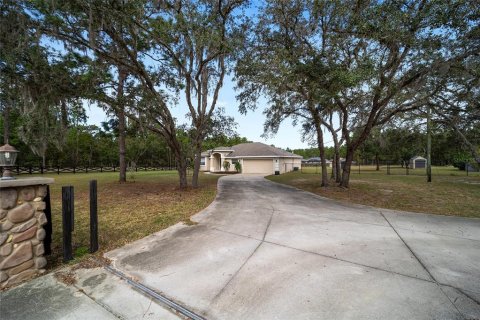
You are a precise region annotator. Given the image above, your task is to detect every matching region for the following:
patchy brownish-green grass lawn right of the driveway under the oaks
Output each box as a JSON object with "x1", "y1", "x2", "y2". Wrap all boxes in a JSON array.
[{"x1": 267, "y1": 166, "x2": 480, "y2": 218}]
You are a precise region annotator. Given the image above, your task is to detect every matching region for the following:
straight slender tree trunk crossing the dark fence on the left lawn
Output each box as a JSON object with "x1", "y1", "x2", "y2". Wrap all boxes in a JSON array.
[{"x1": 116, "y1": 69, "x2": 127, "y2": 183}]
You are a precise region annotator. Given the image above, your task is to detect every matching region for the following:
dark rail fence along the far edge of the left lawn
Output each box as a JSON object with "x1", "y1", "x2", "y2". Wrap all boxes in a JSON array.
[{"x1": 12, "y1": 166, "x2": 175, "y2": 175}]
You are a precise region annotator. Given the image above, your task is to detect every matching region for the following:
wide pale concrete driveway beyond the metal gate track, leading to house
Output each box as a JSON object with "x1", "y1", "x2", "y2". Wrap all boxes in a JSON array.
[{"x1": 107, "y1": 175, "x2": 480, "y2": 319}]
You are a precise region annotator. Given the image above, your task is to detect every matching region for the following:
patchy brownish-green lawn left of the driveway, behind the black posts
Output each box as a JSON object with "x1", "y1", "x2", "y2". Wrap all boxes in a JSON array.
[{"x1": 21, "y1": 171, "x2": 219, "y2": 268}]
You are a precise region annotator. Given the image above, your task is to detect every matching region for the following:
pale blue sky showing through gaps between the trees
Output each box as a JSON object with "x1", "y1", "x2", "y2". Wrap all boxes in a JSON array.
[{"x1": 86, "y1": 78, "x2": 320, "y2": 150}]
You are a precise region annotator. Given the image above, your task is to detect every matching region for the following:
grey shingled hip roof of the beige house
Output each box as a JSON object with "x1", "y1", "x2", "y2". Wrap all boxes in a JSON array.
[{"x1": 223, "y1": 142, "x2": 302, "y2": 158}]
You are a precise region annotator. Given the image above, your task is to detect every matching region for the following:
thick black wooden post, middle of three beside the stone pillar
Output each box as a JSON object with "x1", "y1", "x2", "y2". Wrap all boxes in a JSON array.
[{"x1": 62, "y1": 186, "x2": 74, "y2": 262}]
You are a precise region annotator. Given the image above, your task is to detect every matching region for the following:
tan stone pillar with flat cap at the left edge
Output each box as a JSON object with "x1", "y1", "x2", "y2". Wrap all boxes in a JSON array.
[{"x1": 0, "y1": 178, "x2": 54, "y2": 288}]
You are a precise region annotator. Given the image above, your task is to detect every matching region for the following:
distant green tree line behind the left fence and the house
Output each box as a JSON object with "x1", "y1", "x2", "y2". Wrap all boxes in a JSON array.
[{"x1": 0, "y1": 106, "x2": 248, "y2": 168}]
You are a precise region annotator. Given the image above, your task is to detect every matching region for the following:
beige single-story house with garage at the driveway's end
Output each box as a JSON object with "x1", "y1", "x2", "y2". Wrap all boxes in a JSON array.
[{"x1": 200, "y1": 142, "x2": 302, "y2": 175}]
